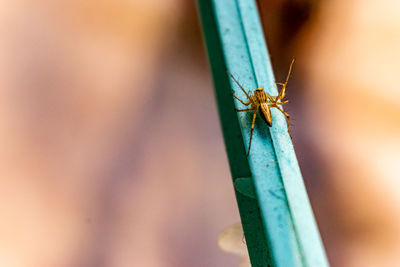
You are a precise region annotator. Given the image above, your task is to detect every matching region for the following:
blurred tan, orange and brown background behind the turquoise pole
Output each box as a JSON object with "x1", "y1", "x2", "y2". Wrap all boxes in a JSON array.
[{"x1": 0, "y1": 0, "x2": 400, "y2": 267}]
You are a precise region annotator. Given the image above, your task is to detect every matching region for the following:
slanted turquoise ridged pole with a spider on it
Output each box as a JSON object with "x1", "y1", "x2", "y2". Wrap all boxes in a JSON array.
[{"x1": 198, "y1": 0, "x2": 329, "y2": 267}]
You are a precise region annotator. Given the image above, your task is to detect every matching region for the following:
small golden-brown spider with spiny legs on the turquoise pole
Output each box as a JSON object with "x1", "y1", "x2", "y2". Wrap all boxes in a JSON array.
[{"x1": 228, "y1": 59, "x2": 295, "y2": 155}]
